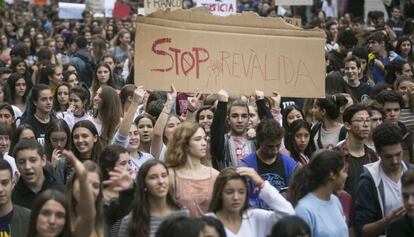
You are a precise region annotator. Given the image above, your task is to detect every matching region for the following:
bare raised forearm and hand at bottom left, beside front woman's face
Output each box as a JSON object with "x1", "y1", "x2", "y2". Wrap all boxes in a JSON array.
[{"x1": 62, "y1": 150, "x2": 96, "y2": 237}]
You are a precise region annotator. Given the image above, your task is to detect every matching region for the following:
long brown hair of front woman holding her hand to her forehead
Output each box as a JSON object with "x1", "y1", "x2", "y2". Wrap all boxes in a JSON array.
[{"x1": 208, "y1": 167, "x2": 249, "y2": 216}]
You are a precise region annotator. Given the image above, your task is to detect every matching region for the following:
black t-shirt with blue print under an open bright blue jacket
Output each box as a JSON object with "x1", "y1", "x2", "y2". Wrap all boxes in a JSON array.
[{"x1": 257, "y1": 154, "x2": 288, "y2": 191}]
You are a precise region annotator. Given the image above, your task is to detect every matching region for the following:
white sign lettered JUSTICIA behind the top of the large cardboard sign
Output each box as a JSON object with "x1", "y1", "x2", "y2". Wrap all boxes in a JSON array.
[{"x1": 197, "y1": 0, "x2": 237, "y2": 16}]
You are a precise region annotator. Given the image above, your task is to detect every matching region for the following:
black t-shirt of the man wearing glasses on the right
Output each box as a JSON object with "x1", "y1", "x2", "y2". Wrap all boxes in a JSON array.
[{"x1": 345, "y1": 153, "x2": 369, "y2": 203}]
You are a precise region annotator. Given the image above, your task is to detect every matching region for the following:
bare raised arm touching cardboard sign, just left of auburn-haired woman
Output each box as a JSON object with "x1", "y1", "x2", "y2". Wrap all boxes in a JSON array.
[{"x1": 150, "y1": 85, "x2": 177, "y2": 159}]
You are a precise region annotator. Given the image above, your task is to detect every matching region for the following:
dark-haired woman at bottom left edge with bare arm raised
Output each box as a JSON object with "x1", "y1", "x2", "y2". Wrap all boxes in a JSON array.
[{"x1": 27, "y1": 151, "x2": 97, "y2": 237}]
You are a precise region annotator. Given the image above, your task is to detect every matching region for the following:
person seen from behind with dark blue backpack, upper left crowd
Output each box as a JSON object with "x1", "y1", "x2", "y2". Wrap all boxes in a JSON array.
[{"x1": 71, "y1": 36, "x2": 96, "y2": 87}]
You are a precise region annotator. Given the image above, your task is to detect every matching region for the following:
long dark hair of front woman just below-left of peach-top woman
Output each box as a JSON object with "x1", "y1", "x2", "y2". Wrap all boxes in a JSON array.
[{"x1": 128, "y1": 159, "x2": 181, "y2": 237}]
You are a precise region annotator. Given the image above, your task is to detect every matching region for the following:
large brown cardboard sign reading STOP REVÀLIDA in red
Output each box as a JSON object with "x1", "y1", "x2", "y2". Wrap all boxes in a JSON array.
[{"x1": 135, "y1": 10, "x2": 325, "y2": 97}]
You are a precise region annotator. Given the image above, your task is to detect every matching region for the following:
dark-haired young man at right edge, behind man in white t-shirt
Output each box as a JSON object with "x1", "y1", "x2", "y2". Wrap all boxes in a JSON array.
[{"x1": 376, "y1": 90, "x2": 414, "y2": 163}]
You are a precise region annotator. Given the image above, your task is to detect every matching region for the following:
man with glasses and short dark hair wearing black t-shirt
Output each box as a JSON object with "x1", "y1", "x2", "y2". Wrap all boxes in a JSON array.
[{"x1": 337, "y1": 104, "x2": 378, "y2": 205}]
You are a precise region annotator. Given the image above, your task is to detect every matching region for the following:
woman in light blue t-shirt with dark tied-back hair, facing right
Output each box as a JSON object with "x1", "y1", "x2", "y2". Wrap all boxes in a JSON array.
[{"x1": 288, "y1": 150, "x2": 348, "y2": 237}]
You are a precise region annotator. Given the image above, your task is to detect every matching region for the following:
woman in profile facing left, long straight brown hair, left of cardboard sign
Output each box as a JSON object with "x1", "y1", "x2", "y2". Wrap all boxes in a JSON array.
[{"x1": 92, "y1": 85, "x2": 122, "y2": 144}]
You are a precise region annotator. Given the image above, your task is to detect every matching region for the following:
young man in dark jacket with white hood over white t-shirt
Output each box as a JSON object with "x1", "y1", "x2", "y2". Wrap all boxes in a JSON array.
[{"x1": 354, "y1": 123, "x2": 409, "y2": 236}]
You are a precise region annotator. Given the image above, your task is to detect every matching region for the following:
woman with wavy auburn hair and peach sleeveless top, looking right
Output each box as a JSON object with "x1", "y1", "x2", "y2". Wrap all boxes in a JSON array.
[{"x1": 165, "y1": 122, "x2": 218, "y2": 217}]
